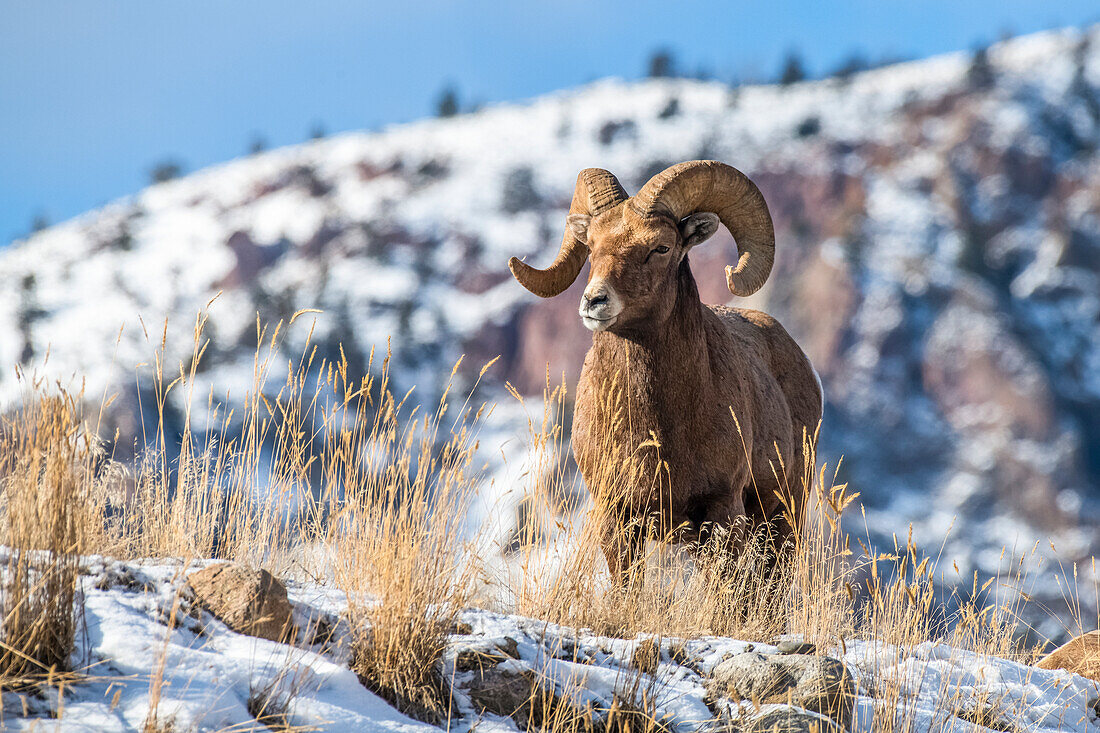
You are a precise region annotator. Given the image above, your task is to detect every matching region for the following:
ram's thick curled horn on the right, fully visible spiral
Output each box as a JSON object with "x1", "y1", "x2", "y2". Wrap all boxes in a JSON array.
[{"x1": 631, "y1": 161, "x2": 776, "y2": 296}]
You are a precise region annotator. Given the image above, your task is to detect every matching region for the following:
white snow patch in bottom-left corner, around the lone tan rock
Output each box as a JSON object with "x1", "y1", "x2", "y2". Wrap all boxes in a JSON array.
[{"x1": 3, "y1": 564, "x2": 438, "y2": 733}]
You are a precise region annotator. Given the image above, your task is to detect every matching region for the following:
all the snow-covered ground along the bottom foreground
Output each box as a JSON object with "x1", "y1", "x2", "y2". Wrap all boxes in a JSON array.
[{"x1": 2, "y1": 558, "x2": 1100, "y2": 733}]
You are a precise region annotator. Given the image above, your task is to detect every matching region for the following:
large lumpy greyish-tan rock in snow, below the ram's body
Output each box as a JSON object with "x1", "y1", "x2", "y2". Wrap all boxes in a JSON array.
[{"x1": 706, "y1": 652, "x2": 856, "y2": 727}]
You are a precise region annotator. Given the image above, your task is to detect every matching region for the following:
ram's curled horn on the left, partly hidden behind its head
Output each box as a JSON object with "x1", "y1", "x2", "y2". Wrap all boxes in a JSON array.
[{"x1": 508, "y1": 168, "x2": 627, "y2": 298}]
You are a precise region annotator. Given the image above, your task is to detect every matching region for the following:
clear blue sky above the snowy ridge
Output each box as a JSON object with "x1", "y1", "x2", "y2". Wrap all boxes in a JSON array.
[{"x1": 0, "y1": 0, "x2": 1100, "y2": 244}]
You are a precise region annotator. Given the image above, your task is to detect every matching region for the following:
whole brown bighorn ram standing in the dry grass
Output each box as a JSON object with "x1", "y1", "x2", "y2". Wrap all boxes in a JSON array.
[{"x1": 508, "y1": 161, "x2": 822, "y2": 584}]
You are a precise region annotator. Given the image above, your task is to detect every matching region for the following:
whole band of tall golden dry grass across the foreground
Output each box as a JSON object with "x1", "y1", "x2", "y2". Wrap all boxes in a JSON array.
[{"x1": 0, "y1": 305, "x2": 1095, "y2": 731}]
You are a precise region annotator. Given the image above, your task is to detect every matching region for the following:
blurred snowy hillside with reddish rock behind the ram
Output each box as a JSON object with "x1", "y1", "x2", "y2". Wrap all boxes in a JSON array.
[{"x1": 0, "y1": 29, "x2": 1100, "y2": 620}]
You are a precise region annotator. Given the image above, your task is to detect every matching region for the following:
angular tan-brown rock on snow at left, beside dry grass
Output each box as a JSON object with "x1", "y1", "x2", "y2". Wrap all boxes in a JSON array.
[{"x1": 187, "y1": 562, "x2": 296, "y2": 642}]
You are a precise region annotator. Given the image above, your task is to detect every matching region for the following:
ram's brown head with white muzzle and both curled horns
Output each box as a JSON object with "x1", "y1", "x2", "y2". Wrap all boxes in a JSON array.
[{"x1": 508, "y1": 161, "x2": 776, "y2": 331}]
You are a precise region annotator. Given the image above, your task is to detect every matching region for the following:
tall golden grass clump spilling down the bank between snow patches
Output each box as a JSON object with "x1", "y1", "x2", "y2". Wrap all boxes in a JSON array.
[{"x1": 325, "y1": 358, "x2": 476, "y2": 723}]
